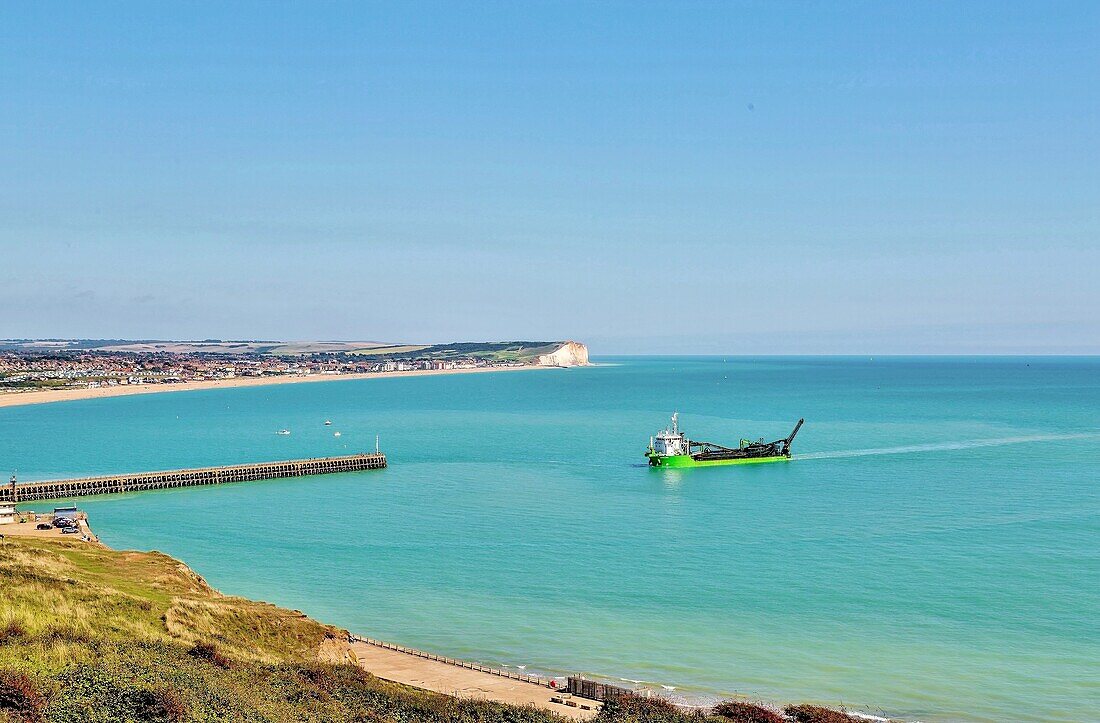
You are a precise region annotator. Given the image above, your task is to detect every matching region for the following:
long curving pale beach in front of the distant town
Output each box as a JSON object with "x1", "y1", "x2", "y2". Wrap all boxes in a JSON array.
[{"x1": 0, "y1": 364, "x2": 550, "y2": 407}]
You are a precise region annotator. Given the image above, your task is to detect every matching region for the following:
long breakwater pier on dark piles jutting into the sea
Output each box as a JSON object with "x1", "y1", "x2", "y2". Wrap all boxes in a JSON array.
[{"x1": 0, "y1": 452, "x2": 386, "y2": 502}]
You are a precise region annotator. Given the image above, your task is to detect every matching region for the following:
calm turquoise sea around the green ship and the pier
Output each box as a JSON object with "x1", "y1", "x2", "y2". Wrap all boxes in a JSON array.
[{"x1": 0, "y1": 358, "x2": 1100, "y2": 721}]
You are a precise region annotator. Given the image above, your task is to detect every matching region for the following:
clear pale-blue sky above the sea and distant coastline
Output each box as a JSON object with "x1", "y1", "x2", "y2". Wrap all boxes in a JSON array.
[{"x1": 0, "y1": 1, "x2": 1100, "y2": 353}]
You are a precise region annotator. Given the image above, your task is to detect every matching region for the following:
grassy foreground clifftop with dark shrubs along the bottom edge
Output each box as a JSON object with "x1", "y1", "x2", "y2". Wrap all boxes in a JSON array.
[{"x1": 0, "y1": 537, "x2": 855, "y2": 723}]
